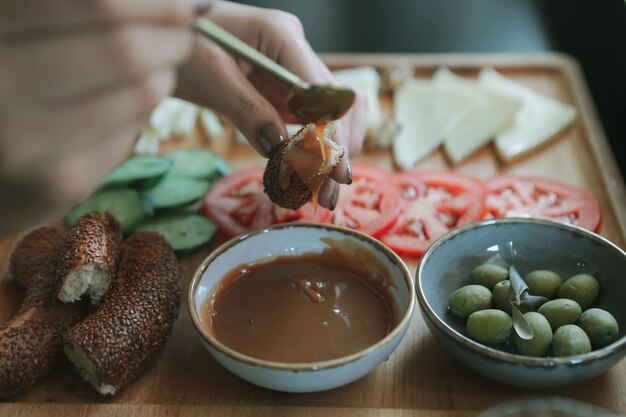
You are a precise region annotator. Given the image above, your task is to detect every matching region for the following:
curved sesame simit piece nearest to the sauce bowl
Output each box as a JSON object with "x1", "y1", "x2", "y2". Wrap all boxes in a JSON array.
[{"x1": 64, "y1": 232, "x2": 180, "y2": 395}]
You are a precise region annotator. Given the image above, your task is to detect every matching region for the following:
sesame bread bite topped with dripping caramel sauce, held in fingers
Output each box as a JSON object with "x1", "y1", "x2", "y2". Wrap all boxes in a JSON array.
[{"x1": 263, "y1": 123, "x2": 345, "y2": 210}]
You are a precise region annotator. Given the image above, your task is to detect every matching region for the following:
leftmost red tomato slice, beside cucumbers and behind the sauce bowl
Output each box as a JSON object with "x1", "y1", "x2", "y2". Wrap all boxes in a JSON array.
[{"x1": 202, "y1": 168, "x2": 328, "y2": 236}]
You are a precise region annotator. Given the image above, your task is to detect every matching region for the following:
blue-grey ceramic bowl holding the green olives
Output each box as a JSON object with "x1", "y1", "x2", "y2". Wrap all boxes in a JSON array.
[{"x1": 416, "y1": 219, "x2": 626, "y2": 388}]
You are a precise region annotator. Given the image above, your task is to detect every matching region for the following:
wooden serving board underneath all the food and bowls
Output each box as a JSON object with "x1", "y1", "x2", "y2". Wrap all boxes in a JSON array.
[{"x1": 0, "y1": 55, "x2": 626, "y2": 416}]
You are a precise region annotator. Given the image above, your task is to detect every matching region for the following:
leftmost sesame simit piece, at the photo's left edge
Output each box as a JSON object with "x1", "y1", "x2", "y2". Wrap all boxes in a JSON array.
[{"x1": 0, "y1": 228, "x2": 85, "y2": 398}]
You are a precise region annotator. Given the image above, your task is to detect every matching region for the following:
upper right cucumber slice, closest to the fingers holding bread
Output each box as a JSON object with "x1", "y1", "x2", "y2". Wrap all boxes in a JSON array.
[{"x1": 167, "y1": 148, "x2": 231, "y2": 179}]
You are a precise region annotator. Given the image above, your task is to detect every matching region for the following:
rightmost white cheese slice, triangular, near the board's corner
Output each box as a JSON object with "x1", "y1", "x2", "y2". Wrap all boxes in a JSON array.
[{"x1": 478, "y1": 68, "x2": 576, "y2": 162}]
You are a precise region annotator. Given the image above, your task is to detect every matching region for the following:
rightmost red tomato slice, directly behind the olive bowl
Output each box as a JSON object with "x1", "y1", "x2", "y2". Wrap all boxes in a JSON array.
[{"x1": 486, "y1": 175, "x2": 602, "y2": 231}]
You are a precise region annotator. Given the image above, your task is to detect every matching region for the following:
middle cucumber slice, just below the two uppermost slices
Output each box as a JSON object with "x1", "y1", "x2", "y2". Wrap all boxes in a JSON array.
[{"x1": 144, "y1": 174, "x2": 209, "y2": 208}]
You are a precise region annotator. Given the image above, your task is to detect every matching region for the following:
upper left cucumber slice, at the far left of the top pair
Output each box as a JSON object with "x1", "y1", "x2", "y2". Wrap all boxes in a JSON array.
[{"x1": 102, "y1": 155, "x2": 172, "y2": 186}]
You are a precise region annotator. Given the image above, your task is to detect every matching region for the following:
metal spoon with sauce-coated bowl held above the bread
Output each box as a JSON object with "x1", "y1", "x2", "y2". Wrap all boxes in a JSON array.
[{"x1": 194, "y1": 17, "x2": 355, "y2": 123}]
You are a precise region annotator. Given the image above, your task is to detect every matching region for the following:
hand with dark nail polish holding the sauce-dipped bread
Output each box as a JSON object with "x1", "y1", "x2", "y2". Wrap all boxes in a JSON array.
[{"x1": 176, "y1": 1, "x2": 366, "y2": 208}]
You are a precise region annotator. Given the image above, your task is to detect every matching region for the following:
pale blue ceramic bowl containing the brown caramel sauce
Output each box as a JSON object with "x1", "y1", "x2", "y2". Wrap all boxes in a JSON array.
[{"x1": 188, "y1": 223, "x2": 415, "y2": 392}]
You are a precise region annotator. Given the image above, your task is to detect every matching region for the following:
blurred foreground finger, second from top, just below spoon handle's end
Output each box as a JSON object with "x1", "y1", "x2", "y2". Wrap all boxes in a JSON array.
[{"x1": 2, "y1": 25, "x2": 193, "y2": 102}]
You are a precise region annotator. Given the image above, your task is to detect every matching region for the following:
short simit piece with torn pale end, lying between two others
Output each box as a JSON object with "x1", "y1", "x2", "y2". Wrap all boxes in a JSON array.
[{"x1": 57, "y1": 212, "x2": 122, "y2": 304}]
